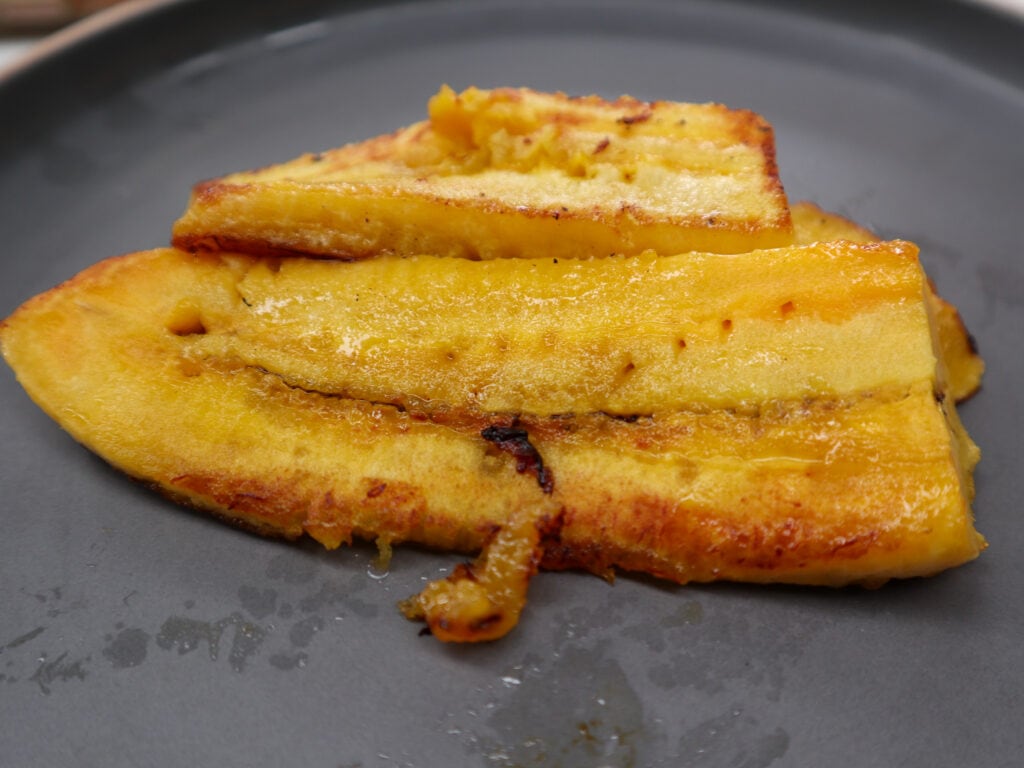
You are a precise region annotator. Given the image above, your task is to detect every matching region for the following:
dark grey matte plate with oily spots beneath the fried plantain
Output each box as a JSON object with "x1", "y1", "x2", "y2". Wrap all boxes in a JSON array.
[{"x1": 0, "y1": 0, "x2": 1024, "y2": 768}]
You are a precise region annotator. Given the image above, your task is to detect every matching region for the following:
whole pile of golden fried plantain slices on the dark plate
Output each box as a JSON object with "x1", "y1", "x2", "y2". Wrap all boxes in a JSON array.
[{"x1": 0, "y1": 87, "x2": 985, "y2": 641}]
